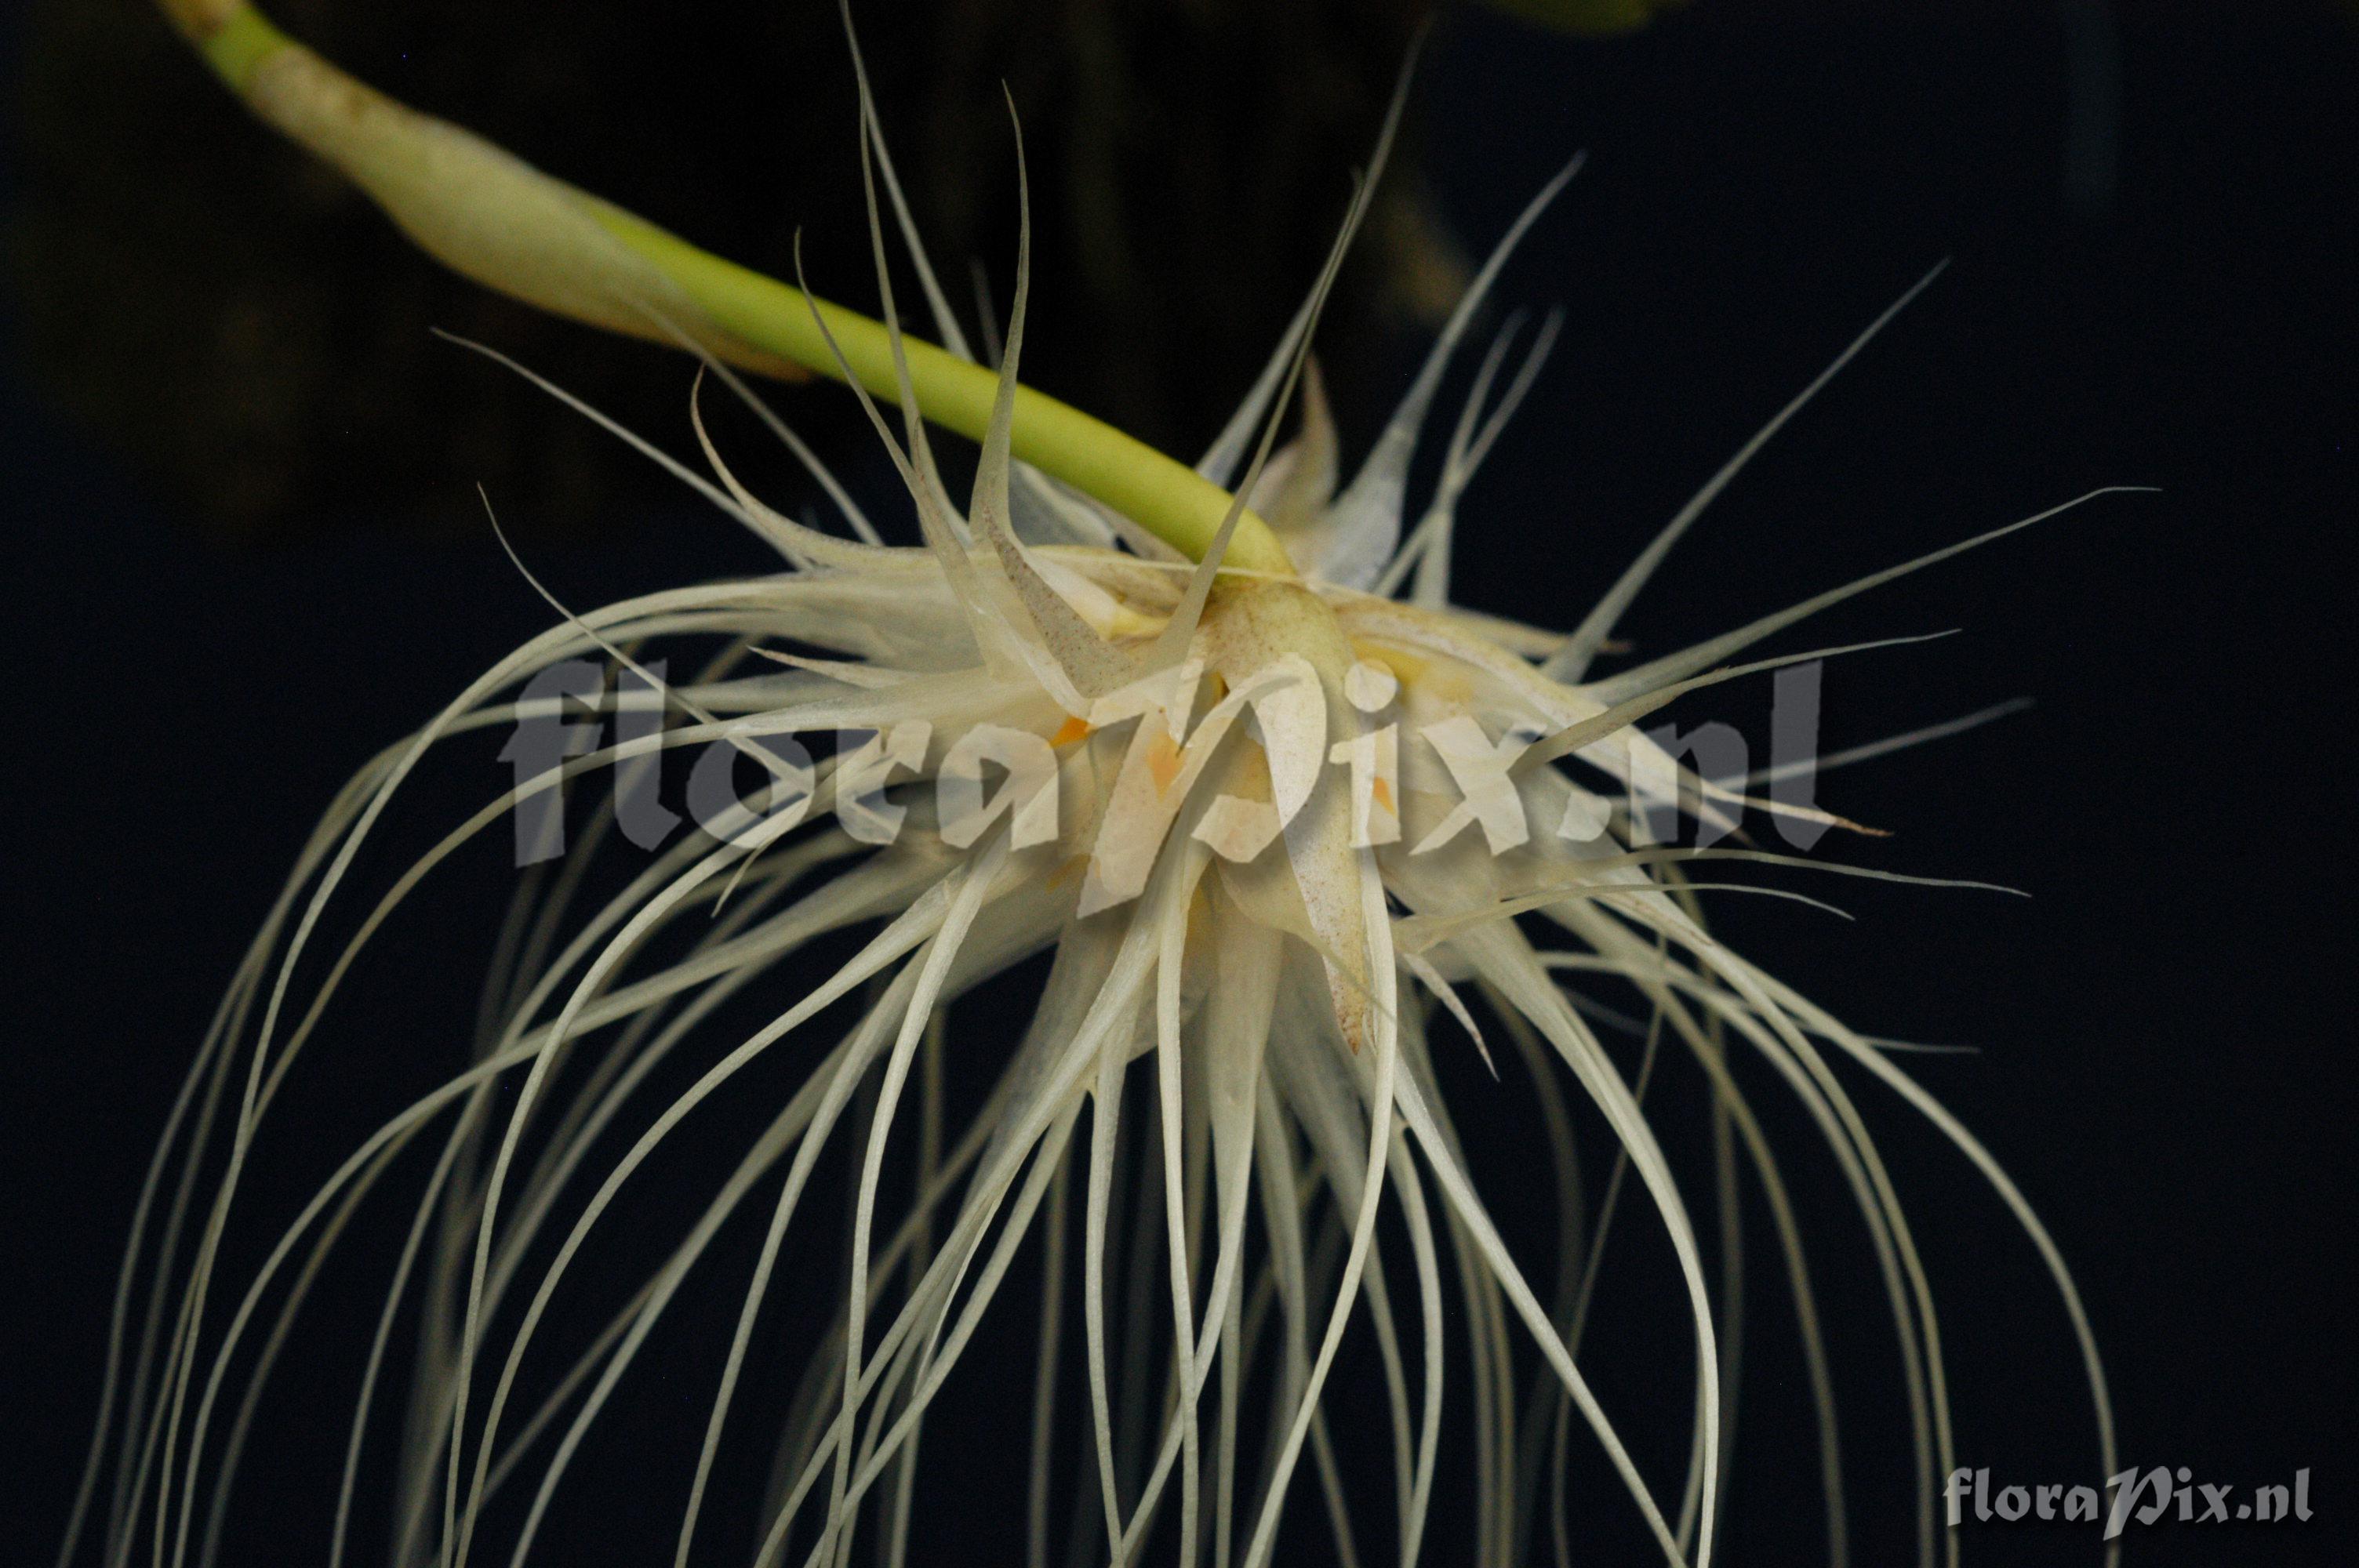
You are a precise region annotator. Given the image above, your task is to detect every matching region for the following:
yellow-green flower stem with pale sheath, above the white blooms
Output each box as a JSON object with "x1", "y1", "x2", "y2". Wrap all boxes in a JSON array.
[{"x1": 161, "y1": 0, "x2": 1292, "y2": 575}]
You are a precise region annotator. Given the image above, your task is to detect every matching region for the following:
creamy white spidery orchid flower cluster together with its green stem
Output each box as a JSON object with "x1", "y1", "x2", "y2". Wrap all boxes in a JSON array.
[{"x1": 64, "y1": 0, "x2": 2142, "y2": 1568}]
